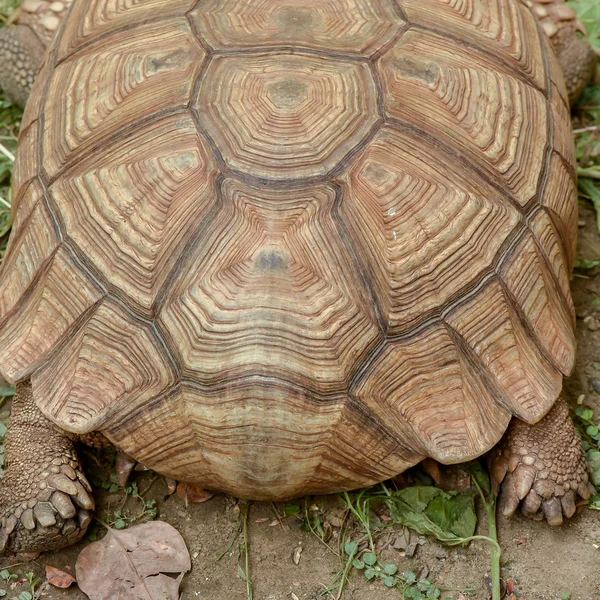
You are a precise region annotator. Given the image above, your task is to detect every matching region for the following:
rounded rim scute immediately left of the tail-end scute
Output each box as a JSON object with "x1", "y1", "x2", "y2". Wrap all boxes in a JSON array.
[{"x1": 31, "y1": 300, "x2": 175, "y2": 434}]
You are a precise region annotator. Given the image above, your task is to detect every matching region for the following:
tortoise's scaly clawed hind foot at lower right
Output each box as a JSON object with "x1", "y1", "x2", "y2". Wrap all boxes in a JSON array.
[{"x1": 491, "y1": 399, "x2": 596, "y2": 525}]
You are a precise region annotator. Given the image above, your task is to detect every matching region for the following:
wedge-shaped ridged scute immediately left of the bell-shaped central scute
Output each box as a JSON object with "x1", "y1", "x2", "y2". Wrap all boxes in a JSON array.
[{"x1": 50, "y1": 116, "x2": 217, "y2": 309}]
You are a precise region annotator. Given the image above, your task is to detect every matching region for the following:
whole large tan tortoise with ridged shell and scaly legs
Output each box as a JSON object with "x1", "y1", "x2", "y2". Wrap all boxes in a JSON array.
[{"x1": 0, "y1": 0, "x2": 593, "y2": 551}]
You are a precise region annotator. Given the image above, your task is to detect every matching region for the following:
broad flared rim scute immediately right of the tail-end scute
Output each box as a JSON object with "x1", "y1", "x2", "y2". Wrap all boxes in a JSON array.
[{"x1": 353, "y1": 322, "x2": 511, "y2": 463}]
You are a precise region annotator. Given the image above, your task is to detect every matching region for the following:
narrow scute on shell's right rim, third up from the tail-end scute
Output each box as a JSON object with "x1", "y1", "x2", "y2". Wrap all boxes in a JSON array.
[{"x1": 500, "y1": 233, "x2": 575, "y2": 377}]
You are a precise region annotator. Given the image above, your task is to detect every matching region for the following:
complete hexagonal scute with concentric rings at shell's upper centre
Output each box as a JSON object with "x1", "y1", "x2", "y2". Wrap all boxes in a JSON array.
[{"x1": 195, "y1": 53, "x2": 380, "y2": 180}]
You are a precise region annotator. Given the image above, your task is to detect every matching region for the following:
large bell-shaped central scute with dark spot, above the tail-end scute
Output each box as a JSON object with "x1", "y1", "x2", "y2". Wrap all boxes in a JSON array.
[{"x1": 159, "y1": 178, "x2": 381, "y2": 393}]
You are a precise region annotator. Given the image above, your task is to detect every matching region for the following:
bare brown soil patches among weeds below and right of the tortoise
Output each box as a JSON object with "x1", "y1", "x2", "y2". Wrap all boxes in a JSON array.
[{"x1": 0, "y1": 206, "x2": 600, "y2": 600}]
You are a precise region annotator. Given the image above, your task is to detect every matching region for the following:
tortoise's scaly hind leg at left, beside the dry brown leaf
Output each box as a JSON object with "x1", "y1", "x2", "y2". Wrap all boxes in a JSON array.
[{"x1": 0, "y1": 382, "x2": 94, "y2": 552}]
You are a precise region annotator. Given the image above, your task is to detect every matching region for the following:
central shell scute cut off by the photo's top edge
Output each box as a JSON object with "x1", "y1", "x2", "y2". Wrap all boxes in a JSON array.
[{"x1": 191, "y1": 0, "x2": 406, "y2": 57}]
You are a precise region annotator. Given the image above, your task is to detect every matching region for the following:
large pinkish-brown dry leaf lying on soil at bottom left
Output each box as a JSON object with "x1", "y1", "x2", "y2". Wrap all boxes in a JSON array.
[{"x1": 75, "y1": 521, "x2": 191, "y2": 600}]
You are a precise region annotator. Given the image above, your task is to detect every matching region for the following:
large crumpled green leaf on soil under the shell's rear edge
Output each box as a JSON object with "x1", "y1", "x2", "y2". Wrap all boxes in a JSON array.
[{"x1": 386, "y1": 486, "x2": 477, "y2": 542}]
